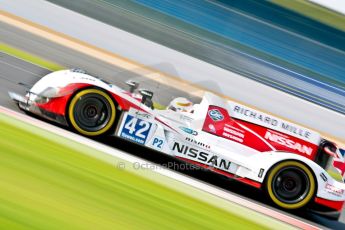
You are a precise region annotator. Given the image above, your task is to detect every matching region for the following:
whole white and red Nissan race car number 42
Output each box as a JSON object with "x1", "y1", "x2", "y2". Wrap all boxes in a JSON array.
[{"x1": 9, "y1": 69, "x2": 345, "y2": 218}]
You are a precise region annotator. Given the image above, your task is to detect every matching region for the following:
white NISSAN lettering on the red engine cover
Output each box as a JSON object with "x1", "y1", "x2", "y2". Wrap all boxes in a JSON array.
[{"x1": 264, "y1": 130, "x2": 313, "y2": 156}]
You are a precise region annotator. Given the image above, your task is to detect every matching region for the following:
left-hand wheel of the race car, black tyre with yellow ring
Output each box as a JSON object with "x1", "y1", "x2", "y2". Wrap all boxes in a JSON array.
[{"x1": 68, "y1": 88, "x2": 116, "y2": 136}]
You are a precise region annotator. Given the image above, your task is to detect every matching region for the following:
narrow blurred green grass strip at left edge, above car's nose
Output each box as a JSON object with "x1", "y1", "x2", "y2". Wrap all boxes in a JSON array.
[{"x1": 0, "y1": 43, "x2": 63, "y2": 71}]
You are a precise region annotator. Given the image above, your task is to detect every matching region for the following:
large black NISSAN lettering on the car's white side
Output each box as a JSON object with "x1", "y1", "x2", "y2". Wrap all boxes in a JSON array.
[{"x1": 172, "y1": 141, "x2": 231, "y2": 171}]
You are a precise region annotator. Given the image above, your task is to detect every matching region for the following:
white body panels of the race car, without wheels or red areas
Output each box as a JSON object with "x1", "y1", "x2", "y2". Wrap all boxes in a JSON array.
[{"x1": 10, "y1": 70, "x2": 345, "y2": 204}]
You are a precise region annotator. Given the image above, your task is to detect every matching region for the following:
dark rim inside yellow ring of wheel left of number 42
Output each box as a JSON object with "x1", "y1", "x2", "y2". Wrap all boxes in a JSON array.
[{"x1": 73, "y1": 94, "x2": 112, "y2": 132}]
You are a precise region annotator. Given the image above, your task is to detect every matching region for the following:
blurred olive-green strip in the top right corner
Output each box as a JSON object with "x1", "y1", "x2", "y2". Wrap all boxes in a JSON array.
[{"x1": 271, "y1": 0, "x2": 345, "y2": 31}]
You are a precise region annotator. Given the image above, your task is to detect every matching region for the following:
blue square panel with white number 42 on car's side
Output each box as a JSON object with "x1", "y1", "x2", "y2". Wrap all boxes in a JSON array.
[{"x1": 120, "y1": 114, "x2": 152, "y2": 145}]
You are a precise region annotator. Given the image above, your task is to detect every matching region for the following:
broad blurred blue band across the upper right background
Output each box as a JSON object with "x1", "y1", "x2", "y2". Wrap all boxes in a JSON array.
[{"x1": 134, "y1": 0, "x2": 345, "y2": 91}]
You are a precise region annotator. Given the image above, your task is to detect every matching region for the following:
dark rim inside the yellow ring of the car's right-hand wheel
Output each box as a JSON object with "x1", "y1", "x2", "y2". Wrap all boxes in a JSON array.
[{"x1": 272, "y1": 167, "x2": 310, "y2": 204}]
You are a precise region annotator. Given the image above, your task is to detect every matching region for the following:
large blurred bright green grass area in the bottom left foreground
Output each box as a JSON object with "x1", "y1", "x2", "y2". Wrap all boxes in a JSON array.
[{"x1": 0, "y1": 114, "x2": 289, "y2": 229}]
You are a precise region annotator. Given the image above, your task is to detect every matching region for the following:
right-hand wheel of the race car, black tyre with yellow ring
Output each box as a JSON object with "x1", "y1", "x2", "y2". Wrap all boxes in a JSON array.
[{"x1": 265, "y1": 161, "x2": 316, "y2": 209}]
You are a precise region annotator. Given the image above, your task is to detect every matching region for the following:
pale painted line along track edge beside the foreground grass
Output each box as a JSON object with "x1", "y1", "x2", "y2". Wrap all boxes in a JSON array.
[{"x1": 0, "y1": 106, "x2": 321, "y2": 229}]
